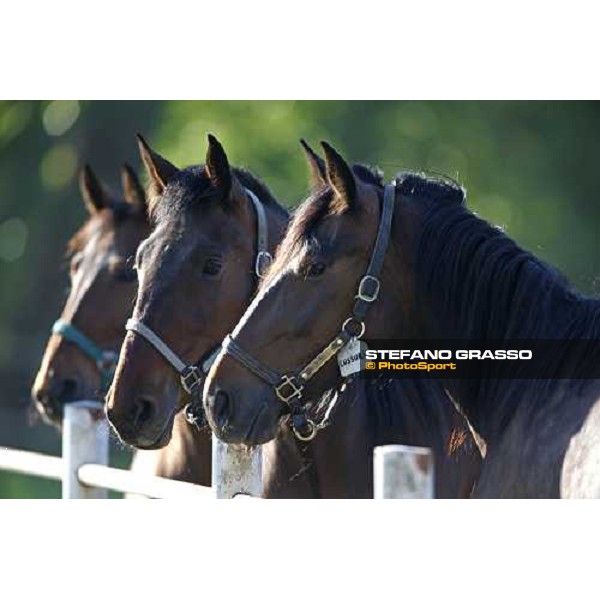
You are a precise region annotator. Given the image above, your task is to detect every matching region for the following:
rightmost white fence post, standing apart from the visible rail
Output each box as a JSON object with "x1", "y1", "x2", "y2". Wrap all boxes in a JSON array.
[{"x1": 373, "y1": 445, "x2": 433, "y2": 499}]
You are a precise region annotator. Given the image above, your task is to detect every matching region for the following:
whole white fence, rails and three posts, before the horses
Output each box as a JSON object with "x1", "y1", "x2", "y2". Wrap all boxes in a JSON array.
[{"x1": 0, "y1": 401, "x2": 433, "y2": 499}]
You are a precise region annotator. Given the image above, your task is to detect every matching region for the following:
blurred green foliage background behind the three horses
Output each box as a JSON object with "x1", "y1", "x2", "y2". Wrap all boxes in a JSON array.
[{"x1": 0, "y1": 101, "x2": 600, "y2": 498}]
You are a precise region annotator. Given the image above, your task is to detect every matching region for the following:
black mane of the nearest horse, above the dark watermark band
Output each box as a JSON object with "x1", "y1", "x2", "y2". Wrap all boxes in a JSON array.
[{"x1": 416, "y1": 203, "x2": 600, "y2": 340}]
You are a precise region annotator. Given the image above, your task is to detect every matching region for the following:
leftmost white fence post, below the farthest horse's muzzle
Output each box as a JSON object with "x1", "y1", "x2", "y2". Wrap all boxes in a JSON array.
[{"x1": 62, "y1": 400, "x2": 108, "y2": 499}]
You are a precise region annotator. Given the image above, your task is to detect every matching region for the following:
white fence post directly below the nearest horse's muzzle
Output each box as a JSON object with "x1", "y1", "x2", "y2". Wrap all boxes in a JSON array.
[{"x1": 212, "y1": 435, "x2": 263, "y2": 498}]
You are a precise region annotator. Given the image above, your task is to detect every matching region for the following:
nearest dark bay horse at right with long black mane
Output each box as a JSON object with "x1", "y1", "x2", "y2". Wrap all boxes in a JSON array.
[{"x1": 204, "y1": 144, "x2": 600, "y2": 497}]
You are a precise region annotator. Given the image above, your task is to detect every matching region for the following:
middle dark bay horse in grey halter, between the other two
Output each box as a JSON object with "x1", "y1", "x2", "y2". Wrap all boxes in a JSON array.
[{"x1": 107, "y1": 137, "x2": 481, "y2": 497}]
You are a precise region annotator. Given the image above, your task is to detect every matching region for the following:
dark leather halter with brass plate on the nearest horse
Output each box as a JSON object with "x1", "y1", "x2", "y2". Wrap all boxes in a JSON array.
[{"x1": 223, "y1": 183, "x2": 396, "y2": 441}]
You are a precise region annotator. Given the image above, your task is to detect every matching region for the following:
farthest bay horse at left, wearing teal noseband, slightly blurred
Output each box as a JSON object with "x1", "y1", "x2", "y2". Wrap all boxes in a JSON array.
[{"x1": 32, "y1": 165, "x2": 211, "y2": 485}]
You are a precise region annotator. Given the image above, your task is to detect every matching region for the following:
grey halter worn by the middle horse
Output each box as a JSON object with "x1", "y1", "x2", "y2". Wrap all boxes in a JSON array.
[{"x1": 125, "y1": 189, "x2": 272, "y2": 427}]
